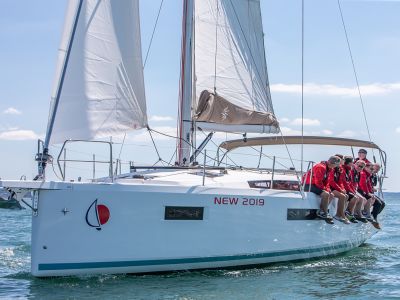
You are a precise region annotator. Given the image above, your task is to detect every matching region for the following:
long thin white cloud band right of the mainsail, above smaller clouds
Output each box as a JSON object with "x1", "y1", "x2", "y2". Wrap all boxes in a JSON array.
[{"x1": 270, "y1": 82, "x2": 400, "y2": 97}]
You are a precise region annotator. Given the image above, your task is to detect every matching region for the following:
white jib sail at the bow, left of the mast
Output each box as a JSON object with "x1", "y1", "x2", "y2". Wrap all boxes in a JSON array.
[{"x1": 50, "y1": 0, "x2": 147, "y2": 143}]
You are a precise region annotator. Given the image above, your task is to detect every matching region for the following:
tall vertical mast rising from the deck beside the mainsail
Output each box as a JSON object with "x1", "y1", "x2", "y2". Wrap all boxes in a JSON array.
[{"x1": 177, "y1": 0, "x2": 194, "y2": 166}]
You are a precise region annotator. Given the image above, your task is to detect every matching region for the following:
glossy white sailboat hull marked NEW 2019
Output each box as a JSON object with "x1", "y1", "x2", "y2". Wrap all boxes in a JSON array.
[{"x1": 3, "y1": 170, "x2": 376, "y2": 276}]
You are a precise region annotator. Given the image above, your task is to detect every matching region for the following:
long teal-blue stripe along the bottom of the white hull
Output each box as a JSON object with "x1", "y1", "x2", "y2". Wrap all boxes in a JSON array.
[{"x1": 38, "y1": 242, "x2": 354, "y2": 271}]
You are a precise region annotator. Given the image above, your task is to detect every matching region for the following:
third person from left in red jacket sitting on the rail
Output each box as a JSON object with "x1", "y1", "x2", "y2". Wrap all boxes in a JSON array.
[{"x1": 340, "y1": 156, "x2": 362, "y2": 223}]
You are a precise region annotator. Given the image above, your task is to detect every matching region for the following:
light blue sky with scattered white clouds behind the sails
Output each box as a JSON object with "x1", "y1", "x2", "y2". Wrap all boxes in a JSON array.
[{"x1": 0, "y1": 0, "x2": 400, "y2": 191}]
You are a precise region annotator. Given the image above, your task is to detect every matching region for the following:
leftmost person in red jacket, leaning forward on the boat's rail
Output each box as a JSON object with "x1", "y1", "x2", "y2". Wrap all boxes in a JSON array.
[{"x1": 303, "y1": 156, "x2": 340, "y2": 220}]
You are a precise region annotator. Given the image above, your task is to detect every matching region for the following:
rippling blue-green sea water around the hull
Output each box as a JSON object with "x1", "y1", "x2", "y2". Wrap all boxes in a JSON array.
[{"x1": 0, "y1": 193, "x2": 400, "y2": 299}]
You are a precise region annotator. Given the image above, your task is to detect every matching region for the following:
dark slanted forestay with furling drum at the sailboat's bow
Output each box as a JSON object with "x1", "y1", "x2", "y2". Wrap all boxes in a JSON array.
[{"x1": 35, "y1": 0, "x2": 83, "y2": 179}]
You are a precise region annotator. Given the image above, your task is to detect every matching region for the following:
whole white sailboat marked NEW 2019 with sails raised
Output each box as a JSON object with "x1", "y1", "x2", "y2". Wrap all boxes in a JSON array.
[{"x1": 0, "y1": 0, "x2": 386, "y2": 277}]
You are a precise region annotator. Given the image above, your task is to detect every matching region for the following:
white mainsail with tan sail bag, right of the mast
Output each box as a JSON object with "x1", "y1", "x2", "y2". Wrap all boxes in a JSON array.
[{"x1": 193, "y1": 0, "x2": 279, "y2": 133}]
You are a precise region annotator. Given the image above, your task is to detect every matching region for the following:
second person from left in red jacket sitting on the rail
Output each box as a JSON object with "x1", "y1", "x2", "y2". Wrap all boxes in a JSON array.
[{"x1": 328, "y1": 154, "x2": 350, "y2": 224}]
